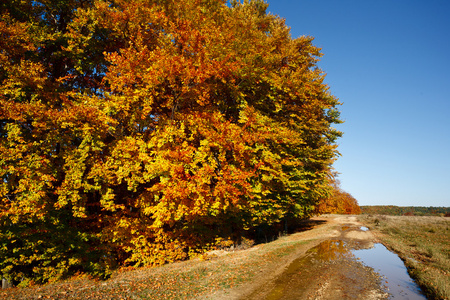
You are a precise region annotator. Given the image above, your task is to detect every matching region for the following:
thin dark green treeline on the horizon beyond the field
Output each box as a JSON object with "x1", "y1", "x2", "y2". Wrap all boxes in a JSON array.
[{"x1": 360, "y1": 205, "x2": 450, "y2": 216}]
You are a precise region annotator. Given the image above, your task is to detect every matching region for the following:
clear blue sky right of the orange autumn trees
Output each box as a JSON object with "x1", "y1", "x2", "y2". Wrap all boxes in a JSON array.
[{"x1": 266, "y1": 0, "x2": 450, "y2": 206}]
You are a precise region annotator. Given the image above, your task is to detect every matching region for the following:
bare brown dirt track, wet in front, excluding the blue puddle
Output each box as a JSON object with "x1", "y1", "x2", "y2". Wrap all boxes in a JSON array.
[{"x1": 211, "y1": 216, "x2": 389, "y2": 300}]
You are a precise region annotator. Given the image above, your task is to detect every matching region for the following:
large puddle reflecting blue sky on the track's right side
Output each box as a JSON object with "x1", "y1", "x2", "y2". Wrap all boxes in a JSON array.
[{"x1": 352, "y1": 244, "x2": 427, "y2": 300}]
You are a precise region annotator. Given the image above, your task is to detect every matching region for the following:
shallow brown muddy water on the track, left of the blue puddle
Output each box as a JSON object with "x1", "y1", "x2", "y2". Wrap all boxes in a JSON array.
[{"x1": 250, "y1": 240, "x2": 386, "y2": 300}]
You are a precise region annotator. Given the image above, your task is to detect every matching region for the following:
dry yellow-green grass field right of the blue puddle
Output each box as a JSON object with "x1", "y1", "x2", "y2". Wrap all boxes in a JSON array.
[{"x1": 359, "y1": 215, "x2": 450, "y2": 300}]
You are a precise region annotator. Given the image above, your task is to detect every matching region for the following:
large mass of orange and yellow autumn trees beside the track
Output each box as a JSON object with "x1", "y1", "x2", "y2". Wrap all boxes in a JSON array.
[{"x1": 0, "y1": 0, "x2": 341, "y2": 282}]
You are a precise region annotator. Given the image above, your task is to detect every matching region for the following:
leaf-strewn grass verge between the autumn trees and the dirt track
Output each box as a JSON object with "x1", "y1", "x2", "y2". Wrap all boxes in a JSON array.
[{"x1": 0, "y1": 223, "x2": 324, "y2": 299}]
